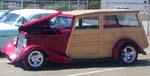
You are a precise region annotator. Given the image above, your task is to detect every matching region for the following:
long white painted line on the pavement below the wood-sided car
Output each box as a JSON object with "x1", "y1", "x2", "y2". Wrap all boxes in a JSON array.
[{"x1": 67, "y1": 68, "x2": 124, "y2": 76}]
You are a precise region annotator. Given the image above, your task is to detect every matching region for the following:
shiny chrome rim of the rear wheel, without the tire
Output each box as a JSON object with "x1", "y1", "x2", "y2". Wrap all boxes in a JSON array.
[{"x1": 122, "y1": 46, "x2": 136, "y2": 63}]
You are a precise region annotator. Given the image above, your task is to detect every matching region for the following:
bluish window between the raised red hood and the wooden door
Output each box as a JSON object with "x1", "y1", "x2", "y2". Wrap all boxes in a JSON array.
[{"x1": 52, "y1": 16, "x2": 72, "y2": 28}]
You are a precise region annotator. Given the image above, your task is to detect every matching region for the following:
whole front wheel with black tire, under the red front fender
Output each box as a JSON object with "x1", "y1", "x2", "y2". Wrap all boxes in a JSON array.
[{"x1": 23, "y1": 50, "x2": 45, "y2": 70}]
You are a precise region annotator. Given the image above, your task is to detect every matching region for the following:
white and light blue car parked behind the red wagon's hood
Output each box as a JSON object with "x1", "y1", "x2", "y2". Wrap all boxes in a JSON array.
[{"x1": 0, "y1": 9, "x2": 57, "y2": 49}]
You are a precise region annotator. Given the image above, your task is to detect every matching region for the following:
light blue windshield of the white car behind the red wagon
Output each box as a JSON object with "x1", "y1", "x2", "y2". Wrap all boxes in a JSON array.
[{"x1": 0, "y1": 13, "x2": 19, "y2": 25}]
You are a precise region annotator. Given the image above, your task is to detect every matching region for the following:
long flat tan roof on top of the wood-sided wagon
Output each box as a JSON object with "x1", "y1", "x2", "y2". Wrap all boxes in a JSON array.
[{"x1": 65, "y1": 9, "x2": 139, "y2": 16}]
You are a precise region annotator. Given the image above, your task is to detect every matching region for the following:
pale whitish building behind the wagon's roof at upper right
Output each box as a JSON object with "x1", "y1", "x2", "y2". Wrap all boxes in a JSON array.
[{"x1": 101, "y1": 0, "x2": 150, "y2": 11}]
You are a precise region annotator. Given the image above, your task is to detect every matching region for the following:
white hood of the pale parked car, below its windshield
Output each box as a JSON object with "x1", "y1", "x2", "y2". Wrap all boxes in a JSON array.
[{"x1": 0, "y1": 23, "x2": 18, "y2": 31}]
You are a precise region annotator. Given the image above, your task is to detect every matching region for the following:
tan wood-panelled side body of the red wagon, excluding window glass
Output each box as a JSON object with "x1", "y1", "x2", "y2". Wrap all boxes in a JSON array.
[{"x1": 66, "y1": 12, "x2": 148, "y2": 59}]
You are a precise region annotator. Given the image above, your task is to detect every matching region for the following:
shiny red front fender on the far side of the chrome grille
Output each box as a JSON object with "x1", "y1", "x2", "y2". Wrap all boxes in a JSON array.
[{"x1": 2, "y1": 41, "x2": 17, "y2": 62}]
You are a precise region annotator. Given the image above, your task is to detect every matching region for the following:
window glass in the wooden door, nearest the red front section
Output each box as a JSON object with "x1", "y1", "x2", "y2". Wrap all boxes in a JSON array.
[{"x1": 75, "y1": 16, "x2": 99, "y2": 29}]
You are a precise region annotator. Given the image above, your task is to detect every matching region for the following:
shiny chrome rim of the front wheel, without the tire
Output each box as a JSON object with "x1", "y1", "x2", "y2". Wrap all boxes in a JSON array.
[{"x1": 28, "y1": 51, "x2": 44, "y2": 68}]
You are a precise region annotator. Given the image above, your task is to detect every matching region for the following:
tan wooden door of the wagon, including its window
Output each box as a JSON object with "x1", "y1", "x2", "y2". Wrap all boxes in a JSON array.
[{"x1": 67, "y1": 15, "x2": 100, "y2": 59}]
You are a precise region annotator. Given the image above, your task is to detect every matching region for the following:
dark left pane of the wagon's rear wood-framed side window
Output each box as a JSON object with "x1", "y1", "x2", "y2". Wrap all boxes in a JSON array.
[{"x1": 103, "y1": 15, "x2": 118, "y2": 28}]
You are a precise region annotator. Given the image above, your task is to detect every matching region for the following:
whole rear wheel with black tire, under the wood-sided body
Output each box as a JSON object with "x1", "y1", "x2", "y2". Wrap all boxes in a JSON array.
[{"x1": 119, "y1": 45, "x2": 138, "y2": 64}]
